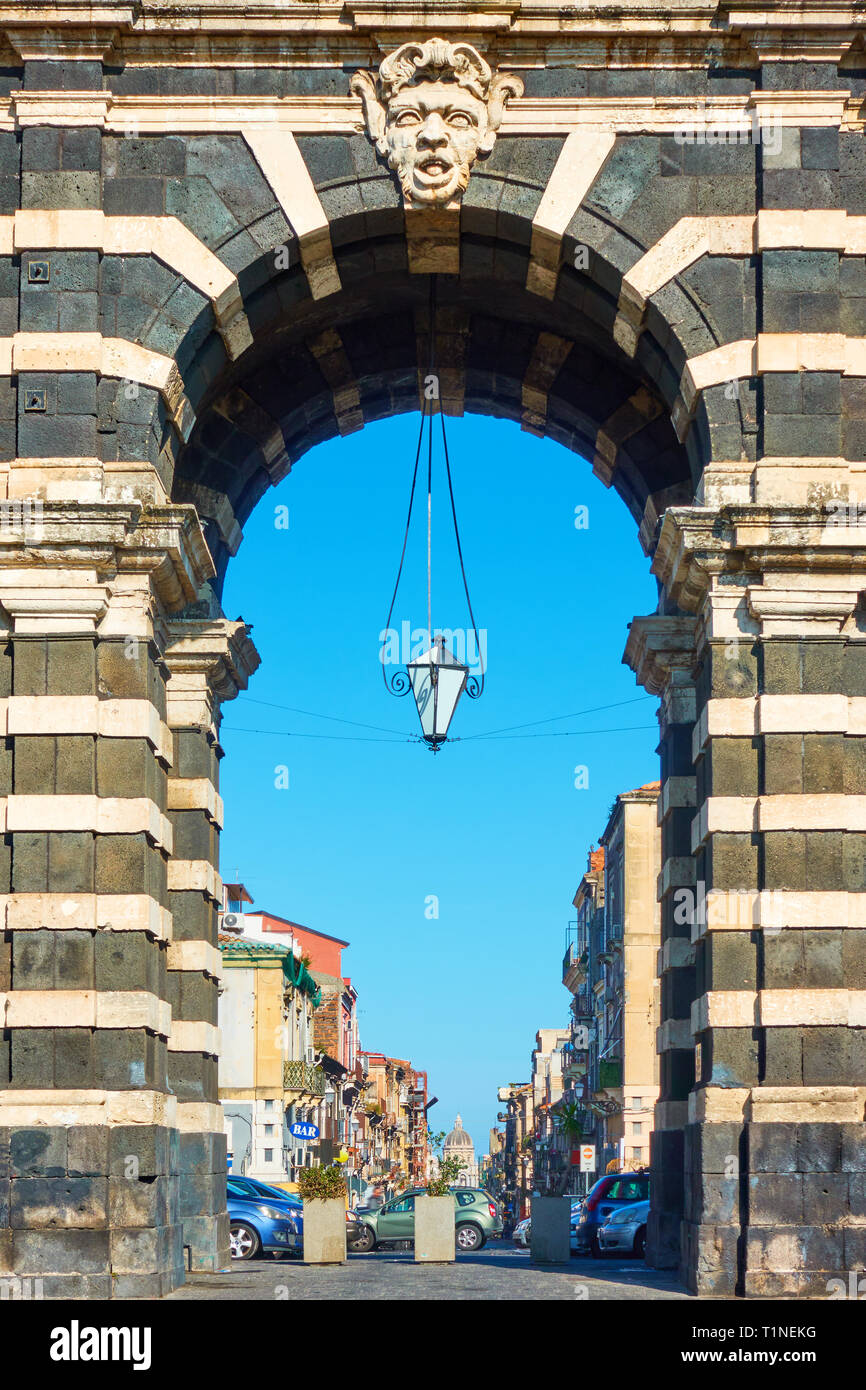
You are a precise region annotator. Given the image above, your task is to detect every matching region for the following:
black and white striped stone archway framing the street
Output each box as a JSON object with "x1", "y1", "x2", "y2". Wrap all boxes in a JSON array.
[{"x1": 0, "y1": 3, "x2": 866, "y2": 1297}]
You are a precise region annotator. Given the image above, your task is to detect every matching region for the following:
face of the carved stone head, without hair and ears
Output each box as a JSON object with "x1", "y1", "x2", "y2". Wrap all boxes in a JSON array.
[{"x1": 385, "y1": 82, "x2": 488, "y2": 206}]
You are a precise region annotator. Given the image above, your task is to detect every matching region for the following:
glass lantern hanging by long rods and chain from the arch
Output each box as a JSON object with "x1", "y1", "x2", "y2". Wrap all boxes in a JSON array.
[{"x1": 382, "y1": 275, "x2": 484, "y2": 753}]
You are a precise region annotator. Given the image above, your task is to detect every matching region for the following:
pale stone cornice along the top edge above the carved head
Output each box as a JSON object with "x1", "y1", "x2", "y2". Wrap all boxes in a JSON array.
[{"x1": 0, "y1": 0, "x2": 866, "y2": 68}]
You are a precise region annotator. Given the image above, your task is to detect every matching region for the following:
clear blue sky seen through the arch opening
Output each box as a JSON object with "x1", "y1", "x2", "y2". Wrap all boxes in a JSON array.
[{"x1": 221, "y1": 416, "x2": 657, "y2": 1152}]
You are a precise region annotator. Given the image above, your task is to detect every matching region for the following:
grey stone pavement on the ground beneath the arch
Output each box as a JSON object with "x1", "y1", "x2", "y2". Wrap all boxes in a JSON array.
[{"x1": 167, "y1": 1241, "x2": 688, "y2": 1302}]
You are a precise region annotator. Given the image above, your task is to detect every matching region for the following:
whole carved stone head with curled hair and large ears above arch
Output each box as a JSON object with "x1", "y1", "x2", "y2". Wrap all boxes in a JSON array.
[{"x1": 352, "y1": 39, "x2": 523, "y2": 209}]
